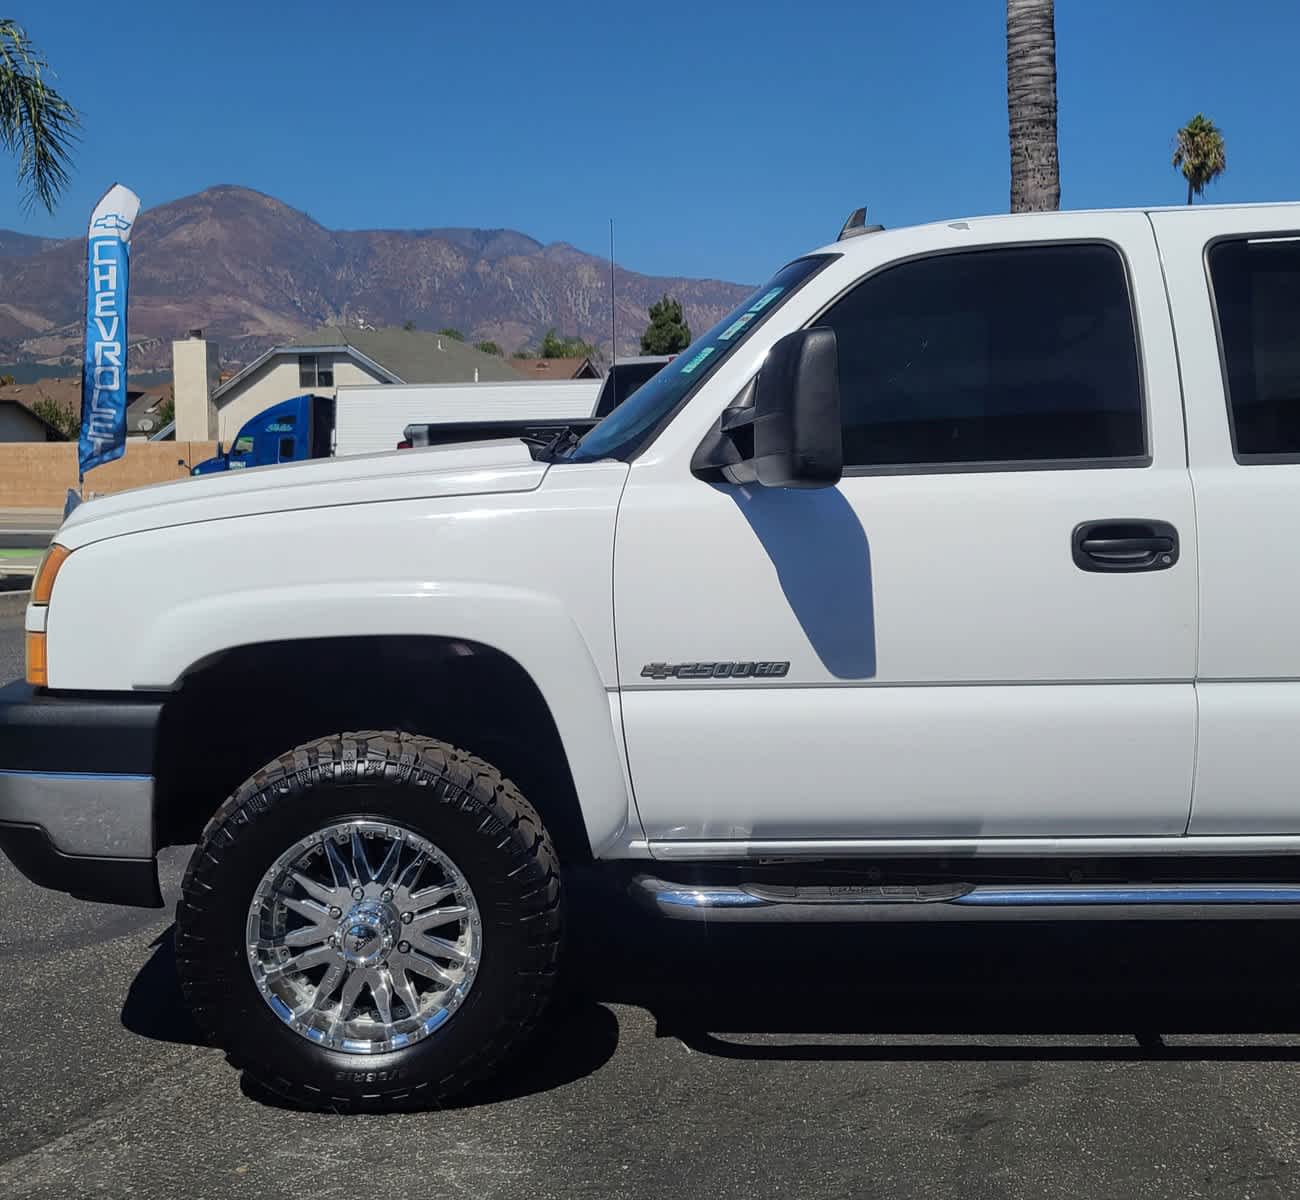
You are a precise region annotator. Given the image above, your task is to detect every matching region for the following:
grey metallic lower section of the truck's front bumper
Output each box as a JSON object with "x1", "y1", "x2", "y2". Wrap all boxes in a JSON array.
[{"x1": 0, "y1": 770, "x2": 153, "y2": 858}]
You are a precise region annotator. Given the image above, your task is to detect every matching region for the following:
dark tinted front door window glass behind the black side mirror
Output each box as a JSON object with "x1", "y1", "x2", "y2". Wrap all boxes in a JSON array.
[{"x1": 818, "y1": 244, "x2": 1145, "y2": 467}]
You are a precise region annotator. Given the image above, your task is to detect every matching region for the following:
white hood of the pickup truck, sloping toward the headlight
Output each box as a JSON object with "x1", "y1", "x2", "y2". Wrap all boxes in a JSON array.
[{"x1": 56, "y1": 441, "x2": 546, "y2": 549}]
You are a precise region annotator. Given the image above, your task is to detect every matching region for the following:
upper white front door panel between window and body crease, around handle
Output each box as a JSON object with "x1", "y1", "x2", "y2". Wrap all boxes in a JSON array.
[{"x1": 615, "y1": 465, "x2": 1196, "y2": 690}]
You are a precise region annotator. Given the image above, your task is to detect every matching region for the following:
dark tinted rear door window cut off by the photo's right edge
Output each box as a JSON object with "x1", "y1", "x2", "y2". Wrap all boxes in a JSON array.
[{"x1": 1209, "y1": 238, "x2": 1300, "y2": 459}]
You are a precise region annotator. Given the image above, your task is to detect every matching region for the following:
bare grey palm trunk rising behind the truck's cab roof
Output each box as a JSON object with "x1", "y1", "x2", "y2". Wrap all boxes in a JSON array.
[{"x1": 1006, "y1": 0, "x2": 1061, "y2": 212}]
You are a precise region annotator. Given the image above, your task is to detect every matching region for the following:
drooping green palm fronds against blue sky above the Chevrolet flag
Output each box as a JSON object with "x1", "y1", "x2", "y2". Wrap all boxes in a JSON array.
[{"x1": 0, "y1": 17, "x2": 81, "y2": 212}]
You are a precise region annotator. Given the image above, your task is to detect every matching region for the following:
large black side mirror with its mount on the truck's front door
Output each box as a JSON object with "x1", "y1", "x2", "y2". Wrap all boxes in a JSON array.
[{"x1": 690, "y1": 329, "x2": 844, "y2": 488}]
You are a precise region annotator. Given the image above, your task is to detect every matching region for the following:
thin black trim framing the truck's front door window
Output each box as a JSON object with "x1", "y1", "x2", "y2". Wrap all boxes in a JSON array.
[{"x1": 805, "y1": 238, "x2": 1154, "y2": 477}]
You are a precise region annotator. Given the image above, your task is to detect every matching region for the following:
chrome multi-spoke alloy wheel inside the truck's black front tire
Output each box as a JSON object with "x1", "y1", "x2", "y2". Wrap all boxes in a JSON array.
[{"x1": 247, "y1": 820, "x2": 482, "y2": 1054}]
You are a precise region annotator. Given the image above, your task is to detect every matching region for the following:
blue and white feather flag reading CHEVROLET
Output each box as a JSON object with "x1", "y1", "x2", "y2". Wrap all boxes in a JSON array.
[{"x1": 78, "y1": 183, "x2": 140, "y2": 475}]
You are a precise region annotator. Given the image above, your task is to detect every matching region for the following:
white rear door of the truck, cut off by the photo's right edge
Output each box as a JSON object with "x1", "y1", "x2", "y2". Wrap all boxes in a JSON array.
[{"x1": 1152, "y1": 204, "x2": 1300, "y2": 835}]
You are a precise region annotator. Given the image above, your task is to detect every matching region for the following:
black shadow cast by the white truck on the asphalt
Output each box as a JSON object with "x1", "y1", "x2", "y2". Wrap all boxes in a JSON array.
[{"x1": 122, "y1": 884, "x2": 1300, "y2": 1105}]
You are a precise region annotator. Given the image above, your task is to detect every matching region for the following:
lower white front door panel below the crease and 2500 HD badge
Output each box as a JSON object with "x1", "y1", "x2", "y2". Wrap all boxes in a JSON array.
[{"x1": 623, "y1": 684, "x2": 1195, "y2": 841}]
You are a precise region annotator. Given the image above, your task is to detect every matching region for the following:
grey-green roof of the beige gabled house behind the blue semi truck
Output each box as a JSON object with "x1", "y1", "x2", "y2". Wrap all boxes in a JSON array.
[{"x1": 212, "y1": 325, "x2": 519, "y2": 400}]
